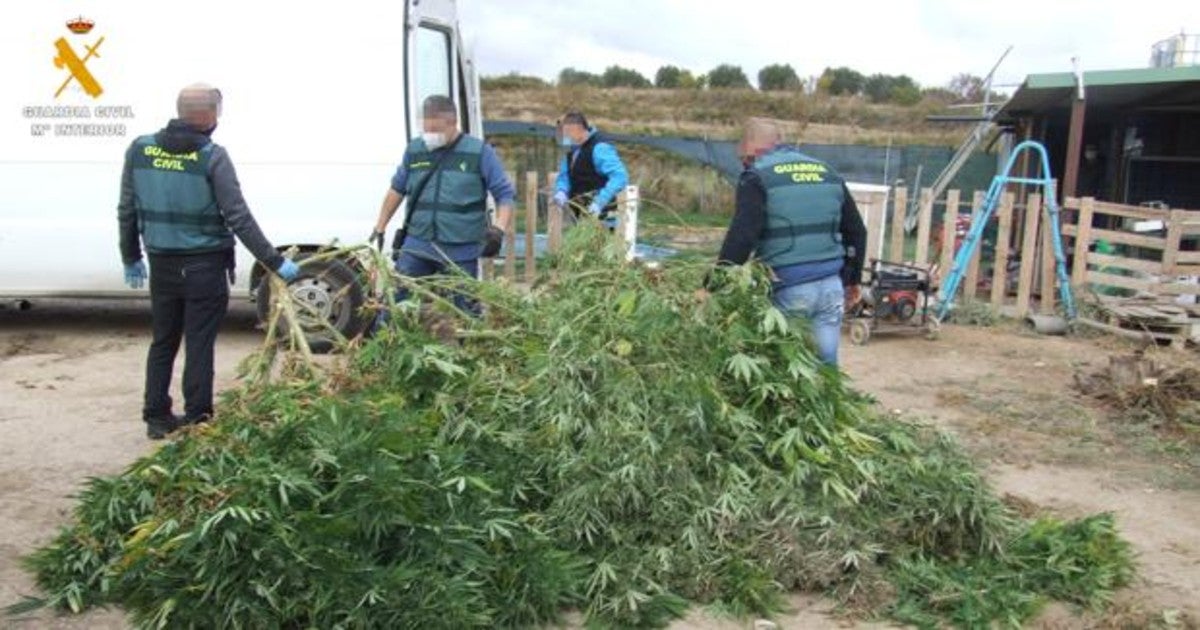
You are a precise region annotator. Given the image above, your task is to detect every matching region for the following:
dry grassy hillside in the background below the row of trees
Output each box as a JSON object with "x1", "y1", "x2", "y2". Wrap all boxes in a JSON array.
[{"x1": 484, "y1": 86, "x2": 965, "y2": 220}]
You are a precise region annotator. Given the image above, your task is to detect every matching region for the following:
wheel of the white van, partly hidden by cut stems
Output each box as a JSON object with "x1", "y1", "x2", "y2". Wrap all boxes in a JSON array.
[{"x1": 256, "y1": 254, "x2": 371, "y2": 353}]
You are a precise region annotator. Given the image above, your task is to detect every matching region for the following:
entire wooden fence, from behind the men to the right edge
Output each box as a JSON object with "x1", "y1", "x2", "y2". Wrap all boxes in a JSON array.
[{"x1": 484, "y1": 173, "x2": 1200, "y2": 338}]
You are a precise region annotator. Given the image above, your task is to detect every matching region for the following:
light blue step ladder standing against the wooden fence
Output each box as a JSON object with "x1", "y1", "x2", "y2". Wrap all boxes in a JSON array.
[{"x1": 937, "y1": 140, "x2": 1075, "y2": 320}]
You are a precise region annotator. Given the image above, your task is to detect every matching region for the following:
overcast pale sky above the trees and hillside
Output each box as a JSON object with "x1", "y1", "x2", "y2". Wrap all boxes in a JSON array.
[{"x1": 458, "y1": 0, "x2": 1200, "y2": 86}]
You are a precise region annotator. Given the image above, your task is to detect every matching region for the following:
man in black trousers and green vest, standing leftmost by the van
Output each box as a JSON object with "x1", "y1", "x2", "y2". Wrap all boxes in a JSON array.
[{"x1": 116, "y1": 84, "x2": 299, "y2": 439}]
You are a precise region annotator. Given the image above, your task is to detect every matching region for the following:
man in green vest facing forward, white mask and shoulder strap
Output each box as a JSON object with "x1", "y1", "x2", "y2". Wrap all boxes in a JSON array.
[{"x1": 371, "y1": 95, "x2": 516, "y2": 313}]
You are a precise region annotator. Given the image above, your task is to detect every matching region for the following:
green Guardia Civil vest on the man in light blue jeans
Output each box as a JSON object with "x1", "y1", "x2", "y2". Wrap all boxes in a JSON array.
[{"x1": 751, "y1": 148, "x2": 846, "y2": 268}]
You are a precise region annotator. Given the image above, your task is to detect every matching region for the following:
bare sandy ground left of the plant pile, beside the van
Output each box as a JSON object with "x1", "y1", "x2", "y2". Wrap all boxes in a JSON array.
[{"x1": 0, "y1": 301, "x2": 260, "y2": 629}]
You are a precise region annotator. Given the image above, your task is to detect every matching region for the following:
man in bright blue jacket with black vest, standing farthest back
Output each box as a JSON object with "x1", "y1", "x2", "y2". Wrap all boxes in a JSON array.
[{"x1": 554, "y1": 112, "x2": 629, "y2": 228}]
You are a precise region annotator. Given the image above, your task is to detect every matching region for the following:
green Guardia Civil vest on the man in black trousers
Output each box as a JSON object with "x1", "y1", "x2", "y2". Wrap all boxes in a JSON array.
[{"x1": 131, "y1": 136, "x2": 234, "y2": 254}]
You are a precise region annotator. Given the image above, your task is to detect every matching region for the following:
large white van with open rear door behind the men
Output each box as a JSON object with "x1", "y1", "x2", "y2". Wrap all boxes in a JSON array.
[{"x1": 0, "y1": 0, "x2": 482, "y2": 343}]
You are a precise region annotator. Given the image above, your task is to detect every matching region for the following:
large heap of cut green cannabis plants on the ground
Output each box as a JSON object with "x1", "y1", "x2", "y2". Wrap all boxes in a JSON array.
[{"x1": 16, "y1": 227, "x2": 1132, "y2": 628}]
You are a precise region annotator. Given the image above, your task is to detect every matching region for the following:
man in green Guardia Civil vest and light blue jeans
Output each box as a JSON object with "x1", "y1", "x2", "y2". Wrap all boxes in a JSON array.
[{"x1": 705, "y1": 119, "x2": 866, "y2": 365}]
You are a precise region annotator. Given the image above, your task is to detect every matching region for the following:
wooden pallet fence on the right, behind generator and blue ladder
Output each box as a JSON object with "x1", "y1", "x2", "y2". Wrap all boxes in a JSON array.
[{"x1": 859, "y1": 188, "x2": 1200, "y2": 326}]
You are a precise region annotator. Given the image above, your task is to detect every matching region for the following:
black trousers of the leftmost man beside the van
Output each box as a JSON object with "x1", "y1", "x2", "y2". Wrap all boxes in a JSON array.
[{"x1": 142, "y1": 252, "x2": 232, "y2": 421}]
